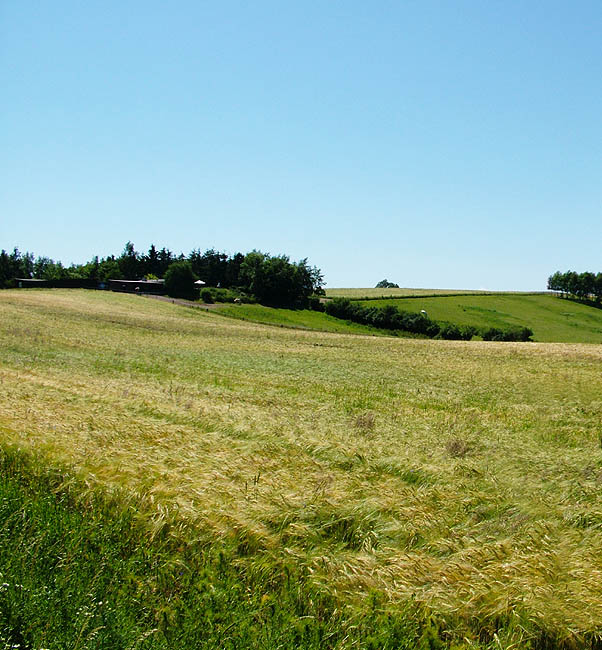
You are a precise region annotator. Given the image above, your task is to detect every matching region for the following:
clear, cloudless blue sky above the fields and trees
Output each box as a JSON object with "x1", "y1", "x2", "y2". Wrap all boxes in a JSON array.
[{"x1": 0, "y1": 0, "x2": 602, "y2": 290}]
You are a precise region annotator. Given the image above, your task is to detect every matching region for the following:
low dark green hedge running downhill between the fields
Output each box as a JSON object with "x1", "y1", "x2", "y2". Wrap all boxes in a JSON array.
[{"x1": 324, "y1": 298, "x2": 533, "y2": 341}]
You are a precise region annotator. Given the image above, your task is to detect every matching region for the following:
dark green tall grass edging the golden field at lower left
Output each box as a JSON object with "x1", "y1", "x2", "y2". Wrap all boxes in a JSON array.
[{"x1": 0, "y1": 448, "x2": 426, "y2": 650}]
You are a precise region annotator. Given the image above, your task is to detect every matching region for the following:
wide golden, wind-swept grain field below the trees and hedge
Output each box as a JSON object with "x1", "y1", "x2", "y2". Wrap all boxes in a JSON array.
[{"x1": 0, "y1": 290, "x2": 602, "y2": 649}]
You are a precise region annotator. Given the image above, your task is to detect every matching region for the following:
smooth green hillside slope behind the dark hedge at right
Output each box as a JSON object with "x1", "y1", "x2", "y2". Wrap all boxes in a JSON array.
[{"x1": 356, "y1": 294, "x2": 602, "y2": 343}]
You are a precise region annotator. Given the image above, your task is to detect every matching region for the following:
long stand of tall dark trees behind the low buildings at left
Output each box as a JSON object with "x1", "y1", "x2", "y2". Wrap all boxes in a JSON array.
[{"x1": 0, "y1": 241, "x2": 324, "y2": 307}]
